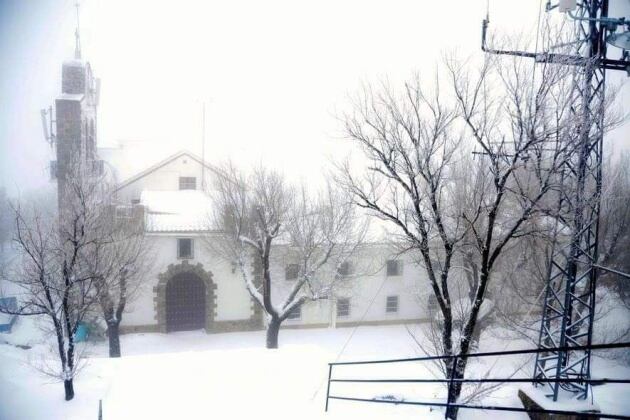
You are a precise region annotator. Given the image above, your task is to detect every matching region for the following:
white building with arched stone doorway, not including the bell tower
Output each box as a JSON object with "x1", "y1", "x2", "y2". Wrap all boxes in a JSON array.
[{"x1": 114, "y1": 152, "x2": 440, "y2": 332}]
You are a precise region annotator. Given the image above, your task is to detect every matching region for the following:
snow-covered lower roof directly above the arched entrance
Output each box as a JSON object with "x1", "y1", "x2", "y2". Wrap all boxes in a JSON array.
[{"x1": 140, "y1": 190, "x2": 212, "y2": 232}]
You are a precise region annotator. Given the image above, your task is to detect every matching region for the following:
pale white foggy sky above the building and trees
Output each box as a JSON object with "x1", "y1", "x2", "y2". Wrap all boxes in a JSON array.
[{"x1": 0, "y1": 0, "x2": 630, "y2": 192}]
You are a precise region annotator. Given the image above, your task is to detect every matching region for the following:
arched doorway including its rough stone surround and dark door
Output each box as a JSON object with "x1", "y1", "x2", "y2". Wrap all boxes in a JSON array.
[{"x1": 154, "y1": 260, "x2": 216, "y2": 332}]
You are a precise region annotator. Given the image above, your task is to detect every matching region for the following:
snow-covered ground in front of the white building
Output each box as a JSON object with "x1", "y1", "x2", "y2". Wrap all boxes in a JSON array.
[{"x1": 0, "y1": 319, "x2": 630, "y2": 420}]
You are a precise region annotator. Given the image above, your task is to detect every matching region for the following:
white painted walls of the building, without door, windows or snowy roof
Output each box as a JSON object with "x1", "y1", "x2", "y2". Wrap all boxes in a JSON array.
[{"x1": 119, "y1": 154, "x2": 470, "y2": 334}]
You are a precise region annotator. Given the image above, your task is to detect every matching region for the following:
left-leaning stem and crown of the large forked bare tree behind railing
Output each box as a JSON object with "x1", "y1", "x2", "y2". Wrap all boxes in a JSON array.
[{"x1": 338, "y1": 77, "x2": 466, "y2": 398}]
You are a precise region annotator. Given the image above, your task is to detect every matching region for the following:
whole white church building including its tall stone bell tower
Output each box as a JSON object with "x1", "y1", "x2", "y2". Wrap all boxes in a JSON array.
[{"x1": 38, "y1": 49, "x2": 454, "y2": 332}]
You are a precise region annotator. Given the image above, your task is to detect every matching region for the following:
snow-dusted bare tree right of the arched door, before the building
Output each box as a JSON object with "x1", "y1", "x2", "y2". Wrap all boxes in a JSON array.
[{"x1": 208, "y1": 165, "x2": 365, "y2": 348}]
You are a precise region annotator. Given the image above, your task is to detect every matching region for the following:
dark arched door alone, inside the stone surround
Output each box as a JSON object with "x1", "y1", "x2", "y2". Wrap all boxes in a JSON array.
[{"x1": 166, "y1": 272, "x2": 206, "y2": 332}]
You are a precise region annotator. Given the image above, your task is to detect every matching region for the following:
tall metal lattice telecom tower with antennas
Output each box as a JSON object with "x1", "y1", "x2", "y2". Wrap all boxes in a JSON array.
[{"x1": 481, "y1": 0, "x2": 630, "y2": 401}]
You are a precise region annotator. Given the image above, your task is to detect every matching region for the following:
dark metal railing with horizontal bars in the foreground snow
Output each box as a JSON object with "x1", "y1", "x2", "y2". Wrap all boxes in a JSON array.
[{"x1": 325, "y1": 342, "x2": 630, "y2": 420}]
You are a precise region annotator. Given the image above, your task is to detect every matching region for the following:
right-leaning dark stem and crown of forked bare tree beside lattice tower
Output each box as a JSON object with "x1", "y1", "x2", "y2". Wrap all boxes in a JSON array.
[{"x1": 447, "y1": 54, "x2": 572, "y2": 418}]
